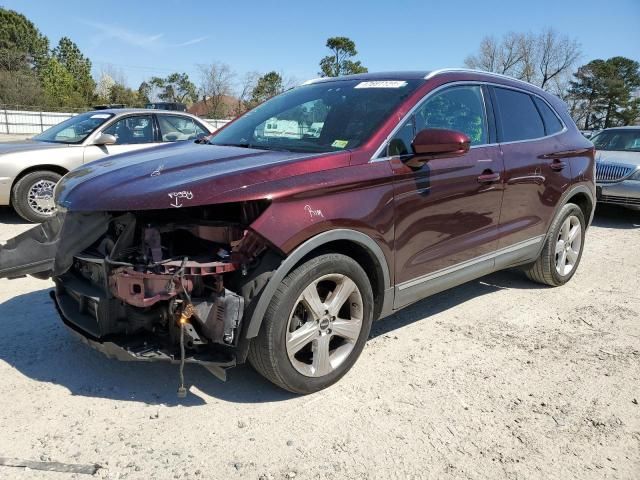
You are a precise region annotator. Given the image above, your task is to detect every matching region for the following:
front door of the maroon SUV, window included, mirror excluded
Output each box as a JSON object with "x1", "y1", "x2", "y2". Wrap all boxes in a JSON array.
[{"x1": 388, "y1": 85, "x2": 504, "y2": 308}]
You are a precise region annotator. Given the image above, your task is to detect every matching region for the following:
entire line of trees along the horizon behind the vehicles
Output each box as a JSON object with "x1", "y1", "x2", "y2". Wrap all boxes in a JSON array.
[{"x1": 0, "y1": 7, "x2": 640, "y2": 129}]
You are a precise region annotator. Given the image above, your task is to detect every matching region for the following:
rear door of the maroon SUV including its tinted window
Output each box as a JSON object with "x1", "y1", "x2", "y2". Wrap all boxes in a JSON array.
[{"x1": 492, "y1": 86, "x2": 571, "y2": 255}]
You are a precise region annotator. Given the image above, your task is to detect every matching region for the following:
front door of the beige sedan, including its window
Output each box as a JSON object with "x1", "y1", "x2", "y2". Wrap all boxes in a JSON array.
[{"x1": 84, "y1": 114, "x2": 161, "y2": 163}]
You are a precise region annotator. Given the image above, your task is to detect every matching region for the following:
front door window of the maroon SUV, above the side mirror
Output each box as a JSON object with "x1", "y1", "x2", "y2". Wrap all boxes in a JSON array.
[{"x1": 415, "y1": 85, "x2": 487, "y2": 145}]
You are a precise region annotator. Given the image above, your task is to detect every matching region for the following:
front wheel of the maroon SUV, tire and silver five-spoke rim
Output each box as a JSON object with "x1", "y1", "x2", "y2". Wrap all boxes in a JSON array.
[{"x1": 249, "y1": 253, "x2": 373, "y2": 394}]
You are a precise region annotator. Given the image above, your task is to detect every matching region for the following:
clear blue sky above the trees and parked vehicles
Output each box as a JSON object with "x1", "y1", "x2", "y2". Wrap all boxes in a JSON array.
[{"x1": 0, "y1": 0, "x2": 640, "y2": 87}]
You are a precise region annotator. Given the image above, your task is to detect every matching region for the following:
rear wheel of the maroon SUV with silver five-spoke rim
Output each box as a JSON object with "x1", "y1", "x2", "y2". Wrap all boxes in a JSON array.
[{"x1": 524, "y1": 203, "x2": 586, "y2": 287}]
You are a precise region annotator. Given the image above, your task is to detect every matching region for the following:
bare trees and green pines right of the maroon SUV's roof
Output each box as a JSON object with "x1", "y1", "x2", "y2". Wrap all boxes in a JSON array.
[{"x1": 465, "y1": 29, "x2": 640, "y2": 130}]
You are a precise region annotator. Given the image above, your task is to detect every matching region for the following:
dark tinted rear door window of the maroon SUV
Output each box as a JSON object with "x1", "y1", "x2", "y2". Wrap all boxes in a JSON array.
[{"x1": 494, "y1": 88, "x2": 545, "y2": 142}]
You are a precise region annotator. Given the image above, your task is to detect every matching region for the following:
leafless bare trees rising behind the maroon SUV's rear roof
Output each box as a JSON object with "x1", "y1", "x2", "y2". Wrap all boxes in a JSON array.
[{"x1": 465, "y1": 28, "x2": 580, "y2": 94}]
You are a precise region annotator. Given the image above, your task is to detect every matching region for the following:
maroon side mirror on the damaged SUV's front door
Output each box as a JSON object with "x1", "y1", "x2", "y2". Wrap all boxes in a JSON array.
[{"x1": 407, "y1": 128, "x2": 471, "y2": 166}]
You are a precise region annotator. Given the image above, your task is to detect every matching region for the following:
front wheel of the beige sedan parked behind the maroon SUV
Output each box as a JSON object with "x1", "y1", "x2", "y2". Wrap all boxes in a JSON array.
[{"x1": 11, "y1": 170, "x2": 62, "y2": 223}]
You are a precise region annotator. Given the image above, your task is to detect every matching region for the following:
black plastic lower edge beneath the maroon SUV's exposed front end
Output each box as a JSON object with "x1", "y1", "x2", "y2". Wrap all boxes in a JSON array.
[{"x1": 50, "y1": 288, "x2": 236, "y2": 381}]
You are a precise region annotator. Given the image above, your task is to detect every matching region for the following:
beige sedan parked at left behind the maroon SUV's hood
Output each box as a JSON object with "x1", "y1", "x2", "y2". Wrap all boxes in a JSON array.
[{"x1": 0, "y1": 108, "x2": 215, "y2": 222}]
